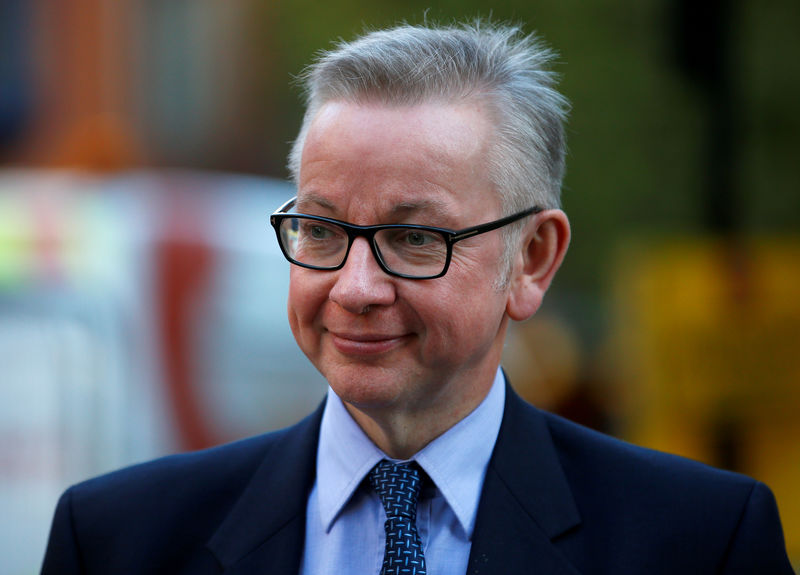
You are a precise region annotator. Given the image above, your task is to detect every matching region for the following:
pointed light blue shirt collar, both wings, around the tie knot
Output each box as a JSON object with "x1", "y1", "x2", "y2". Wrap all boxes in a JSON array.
[{"x1": 317, "y1": 368, "x2": 505, "y2": 538}]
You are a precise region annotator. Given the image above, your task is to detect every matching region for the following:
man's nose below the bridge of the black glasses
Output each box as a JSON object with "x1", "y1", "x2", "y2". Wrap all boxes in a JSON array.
[{"x1": 329, "y1": 238, "x2": 396, "y2": 315}]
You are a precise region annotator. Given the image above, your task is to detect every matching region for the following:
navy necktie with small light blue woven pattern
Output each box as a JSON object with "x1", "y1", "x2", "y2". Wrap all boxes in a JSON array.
[{"x1": 369, "y1": 459, "x2": 426, "y2": 575}]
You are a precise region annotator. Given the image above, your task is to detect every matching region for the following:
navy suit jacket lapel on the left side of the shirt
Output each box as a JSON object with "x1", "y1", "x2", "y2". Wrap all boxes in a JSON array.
[{"x1": 208, "y1": 406, "x2": 322, "y2": 575}]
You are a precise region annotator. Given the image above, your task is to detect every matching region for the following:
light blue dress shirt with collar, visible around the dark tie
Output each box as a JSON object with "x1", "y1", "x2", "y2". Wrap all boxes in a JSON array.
[{"x1": 300, "y1": 369, "x2": 505, "y2": 575}]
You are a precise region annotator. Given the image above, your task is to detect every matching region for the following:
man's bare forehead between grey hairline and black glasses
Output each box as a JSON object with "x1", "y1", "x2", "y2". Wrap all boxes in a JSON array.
[{"x1": 298, "y1": 102, "x2": 497, "y2": 222}]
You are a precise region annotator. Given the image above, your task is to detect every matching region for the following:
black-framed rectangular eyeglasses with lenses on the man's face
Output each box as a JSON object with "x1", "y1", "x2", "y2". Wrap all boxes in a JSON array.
[{"x1": 269, "y1": 197, "x2": 542, "y2": 280}]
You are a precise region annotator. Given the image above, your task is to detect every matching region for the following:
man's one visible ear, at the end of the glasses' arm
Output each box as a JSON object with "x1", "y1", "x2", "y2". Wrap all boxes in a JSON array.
[{"x1": 506, "y1": 210, "x2": 570, "y2": 321}]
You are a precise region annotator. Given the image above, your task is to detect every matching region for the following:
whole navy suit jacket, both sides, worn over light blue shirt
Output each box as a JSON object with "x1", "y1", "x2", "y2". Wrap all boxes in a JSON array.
[{"x1": 42, "y1": 387, "x2": 792, "y2": 575}]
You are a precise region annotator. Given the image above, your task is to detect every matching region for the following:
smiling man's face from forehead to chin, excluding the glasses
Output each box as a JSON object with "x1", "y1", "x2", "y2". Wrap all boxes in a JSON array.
[{"x1": 289, "y1": 102, "x2": 507, "y2": 424}]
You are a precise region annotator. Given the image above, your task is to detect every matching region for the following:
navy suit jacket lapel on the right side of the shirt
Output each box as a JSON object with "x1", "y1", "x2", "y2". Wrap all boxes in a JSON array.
[{"x1": 467, "y1": 386, "x2": 580, "y2": 575}]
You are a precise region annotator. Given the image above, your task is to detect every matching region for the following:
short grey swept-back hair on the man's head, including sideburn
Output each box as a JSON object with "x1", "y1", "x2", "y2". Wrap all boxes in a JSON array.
[{"x1": 289, "y1": 21, "x2": 569, "y2": 282}]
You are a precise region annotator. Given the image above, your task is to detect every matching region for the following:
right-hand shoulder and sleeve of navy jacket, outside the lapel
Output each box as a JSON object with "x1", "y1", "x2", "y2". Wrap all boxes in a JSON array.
[{"x1": 544, "y1": 408, "x2": 791, "y2": 574}]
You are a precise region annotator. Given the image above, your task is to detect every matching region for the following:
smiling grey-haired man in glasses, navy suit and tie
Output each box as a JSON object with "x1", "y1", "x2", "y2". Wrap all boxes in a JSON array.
[{"x1": 43, "y1": 20, "x2": 792, "y2": 575}]
